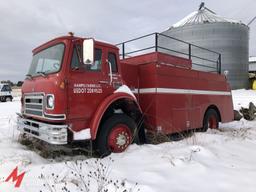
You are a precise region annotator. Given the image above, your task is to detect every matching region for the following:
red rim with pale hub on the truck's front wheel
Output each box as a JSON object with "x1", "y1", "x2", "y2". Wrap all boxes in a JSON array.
[{"x1": 108, "y1": 124, "x2": 132, "y2": 153}]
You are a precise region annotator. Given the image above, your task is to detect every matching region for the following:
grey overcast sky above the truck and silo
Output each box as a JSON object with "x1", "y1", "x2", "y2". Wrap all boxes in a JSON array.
[{"x1": 0, "y1": 0, "x2": 256, "y2": 82}]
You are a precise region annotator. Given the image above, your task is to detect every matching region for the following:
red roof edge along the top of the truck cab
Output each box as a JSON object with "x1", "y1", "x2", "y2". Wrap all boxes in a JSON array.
[{"x1": 32, "y1": 35, "x2": 118, "y2": 54}]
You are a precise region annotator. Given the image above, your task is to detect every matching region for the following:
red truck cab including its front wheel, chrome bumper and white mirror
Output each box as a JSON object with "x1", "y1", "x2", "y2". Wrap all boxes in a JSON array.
[{"x1": 18, "y1": 35, "x2": 141, "y2": 154}]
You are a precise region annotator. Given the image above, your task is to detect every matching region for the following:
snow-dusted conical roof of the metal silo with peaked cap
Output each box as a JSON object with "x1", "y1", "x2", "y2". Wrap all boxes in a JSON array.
[{"x1": 170, "y1": 4, "x2": 242, "y2": 28}]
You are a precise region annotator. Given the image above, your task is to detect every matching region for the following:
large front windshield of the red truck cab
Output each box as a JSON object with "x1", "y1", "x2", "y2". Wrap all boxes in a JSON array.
[{"x1": 28, "y1": 43, "x2": 65, "y2": 76}]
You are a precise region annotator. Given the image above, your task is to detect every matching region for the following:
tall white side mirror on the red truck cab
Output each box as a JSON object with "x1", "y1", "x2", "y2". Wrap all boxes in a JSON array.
[{"x1": 83, "y1": 39, "x2": 94, "y2": 65}]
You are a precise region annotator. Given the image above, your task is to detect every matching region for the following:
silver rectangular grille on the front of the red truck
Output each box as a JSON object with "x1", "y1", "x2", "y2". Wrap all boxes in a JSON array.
[{"x1": 24, "y1": 93, "x2": 44, "y2": 116}]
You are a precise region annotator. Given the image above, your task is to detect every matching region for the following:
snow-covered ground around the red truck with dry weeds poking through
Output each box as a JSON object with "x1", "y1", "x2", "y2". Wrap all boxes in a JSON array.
[{"x1": 0, "y1": 90, "x2": 256, "y2": 192}]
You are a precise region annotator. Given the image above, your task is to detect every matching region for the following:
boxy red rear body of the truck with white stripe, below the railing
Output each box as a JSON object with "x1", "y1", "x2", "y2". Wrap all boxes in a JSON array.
[{"x1": 121, "y1": 52, "x2": 233, "y2": 134}]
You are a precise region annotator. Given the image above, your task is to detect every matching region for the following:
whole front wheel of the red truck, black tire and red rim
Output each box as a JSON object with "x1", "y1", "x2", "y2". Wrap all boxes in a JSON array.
[{"x1": 96, "y1": 114, "x2": 137, "y2": 157}]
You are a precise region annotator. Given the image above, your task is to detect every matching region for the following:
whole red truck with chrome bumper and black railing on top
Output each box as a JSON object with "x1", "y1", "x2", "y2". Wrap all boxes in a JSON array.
[{"x1": 18, "y1": 33, "x2": 233, "y2": 155}]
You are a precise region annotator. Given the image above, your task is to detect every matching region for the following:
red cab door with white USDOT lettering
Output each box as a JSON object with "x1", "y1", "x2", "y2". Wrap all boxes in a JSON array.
[{"x1": 68, "y1": 45, "x2": 113, "y2": 128}]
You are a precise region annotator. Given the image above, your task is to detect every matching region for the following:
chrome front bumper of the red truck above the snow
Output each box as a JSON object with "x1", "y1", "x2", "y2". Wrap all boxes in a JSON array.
[{"x1": 17, "y1": 116, "x2": 68, "y2": 145}]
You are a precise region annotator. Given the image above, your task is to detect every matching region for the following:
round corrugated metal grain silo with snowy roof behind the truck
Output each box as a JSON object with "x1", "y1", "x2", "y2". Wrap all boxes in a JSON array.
[{"x1": 158, "y1": 3, "x2": 249, "y2": 89}]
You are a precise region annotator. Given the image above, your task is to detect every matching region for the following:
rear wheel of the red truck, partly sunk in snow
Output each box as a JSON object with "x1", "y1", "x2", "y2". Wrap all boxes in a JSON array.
[{"x1": 202, "y1": 109, "x2": 220, "y2": 132}]
